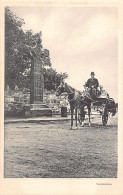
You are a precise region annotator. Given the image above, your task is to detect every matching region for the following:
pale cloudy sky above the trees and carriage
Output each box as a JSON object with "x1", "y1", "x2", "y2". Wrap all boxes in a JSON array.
[{"x1": 10, "y1": 6, "x2": 118, "y2": 101}]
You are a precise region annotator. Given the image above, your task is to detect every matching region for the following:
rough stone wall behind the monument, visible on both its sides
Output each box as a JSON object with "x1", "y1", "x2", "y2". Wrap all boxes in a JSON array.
[{"x1": 4, "y1": 86, "x2": 70, "y2": 117}]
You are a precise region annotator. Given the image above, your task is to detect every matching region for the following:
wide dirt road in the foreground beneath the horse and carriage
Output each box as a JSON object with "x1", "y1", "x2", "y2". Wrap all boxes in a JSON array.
[{"x1": 4, "y1": 114, "x2": 118, "y2": 178}]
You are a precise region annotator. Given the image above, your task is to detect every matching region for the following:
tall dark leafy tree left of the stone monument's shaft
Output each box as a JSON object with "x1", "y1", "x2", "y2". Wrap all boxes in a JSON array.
[{"x1": 5, "y1": 7, "x2": 45, "y2": 88}]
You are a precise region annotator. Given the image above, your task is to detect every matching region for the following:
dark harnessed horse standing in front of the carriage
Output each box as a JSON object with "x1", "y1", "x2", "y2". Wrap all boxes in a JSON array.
[{"x1": 56, "y1": 82, "x2": 92, "y2": 129}]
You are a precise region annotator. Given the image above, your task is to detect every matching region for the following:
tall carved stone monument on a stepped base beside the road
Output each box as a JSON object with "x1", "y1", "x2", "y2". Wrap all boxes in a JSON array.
[{"x1": 25, "y1": 36, "x2": 52, "y2": 117}]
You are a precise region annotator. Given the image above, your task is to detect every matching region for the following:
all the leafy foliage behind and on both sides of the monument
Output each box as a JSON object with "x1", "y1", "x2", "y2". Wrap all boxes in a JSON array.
[{"x1": 5, "y1": 7, "x2": 67, "y2": 90}]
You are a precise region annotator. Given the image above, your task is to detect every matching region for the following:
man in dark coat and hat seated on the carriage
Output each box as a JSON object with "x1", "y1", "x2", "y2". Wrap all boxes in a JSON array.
[{"x1": 86, "y1": 72, "x2": 99, "y2": 99}]
